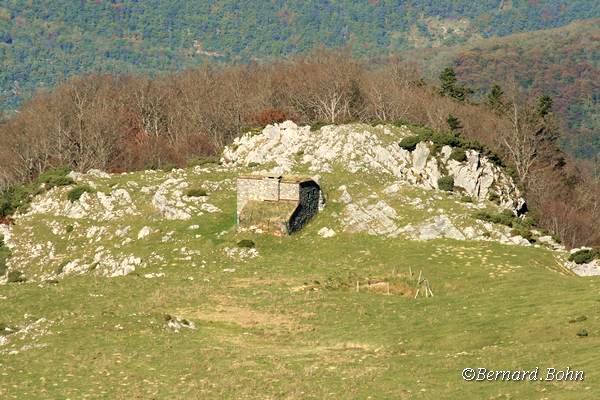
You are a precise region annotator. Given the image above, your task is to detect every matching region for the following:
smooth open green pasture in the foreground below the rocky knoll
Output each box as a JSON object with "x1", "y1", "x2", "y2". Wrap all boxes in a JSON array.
[{"x1": 0, "y1": 232, "x2": 600, "y2": 399}]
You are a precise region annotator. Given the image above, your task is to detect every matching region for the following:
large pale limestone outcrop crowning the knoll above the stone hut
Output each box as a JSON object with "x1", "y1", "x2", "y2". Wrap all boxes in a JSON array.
[{"x1": 221, "y1": 121, "x2": 523, "y2": 211}]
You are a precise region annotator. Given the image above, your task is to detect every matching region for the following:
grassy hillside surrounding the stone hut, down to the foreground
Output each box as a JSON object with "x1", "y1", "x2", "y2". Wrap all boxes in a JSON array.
[{"x1": 0, "y1": 126, "x2": 600, "y2": 399}]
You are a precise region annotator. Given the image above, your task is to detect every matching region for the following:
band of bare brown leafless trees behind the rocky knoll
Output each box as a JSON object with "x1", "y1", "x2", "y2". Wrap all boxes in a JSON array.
[{"x1": 0, "y1": 50, "x2": 600, "y2": 246}]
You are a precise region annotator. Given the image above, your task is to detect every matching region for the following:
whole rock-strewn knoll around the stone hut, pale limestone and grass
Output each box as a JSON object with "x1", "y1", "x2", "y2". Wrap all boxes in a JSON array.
[{"x1": 0, "y1": 121, "x2": 600, "y2": 283}]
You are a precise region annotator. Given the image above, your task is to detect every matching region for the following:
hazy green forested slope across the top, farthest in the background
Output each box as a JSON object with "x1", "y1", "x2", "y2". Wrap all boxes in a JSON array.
[{"x1": 0, "y1": 0, "x2": 600, "y2": 109}]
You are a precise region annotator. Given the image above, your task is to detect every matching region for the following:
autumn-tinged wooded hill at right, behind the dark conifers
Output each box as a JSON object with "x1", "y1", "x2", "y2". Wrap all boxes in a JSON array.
[{"x1": 434, "y1": 20, "x2": 600, "y2": 158}]
